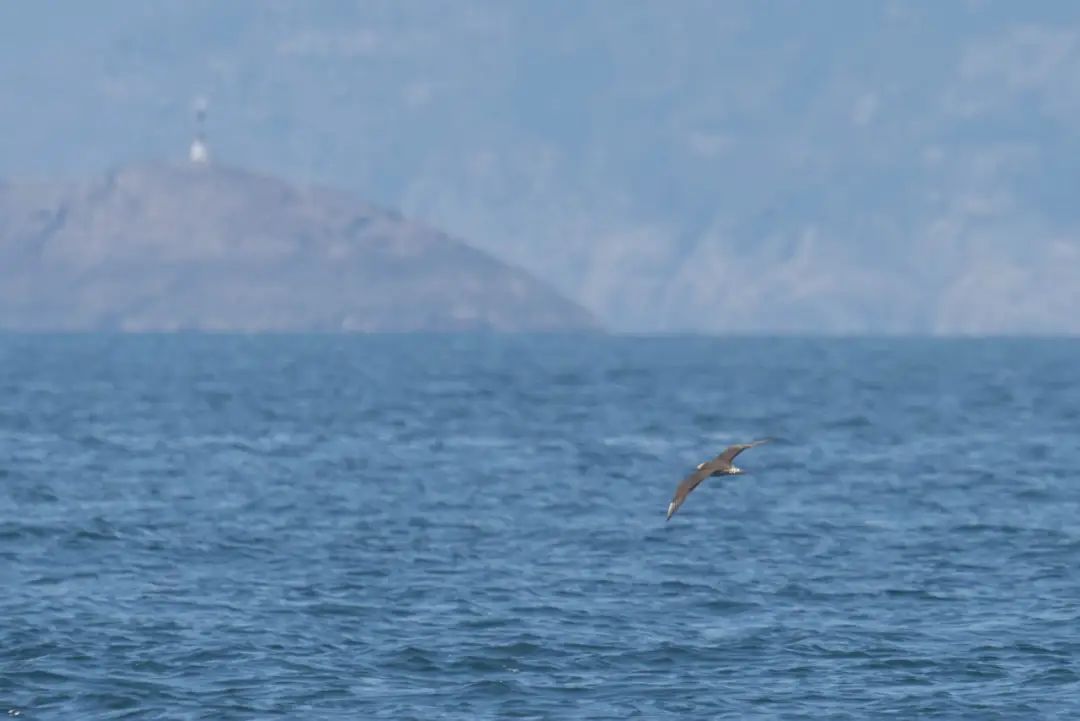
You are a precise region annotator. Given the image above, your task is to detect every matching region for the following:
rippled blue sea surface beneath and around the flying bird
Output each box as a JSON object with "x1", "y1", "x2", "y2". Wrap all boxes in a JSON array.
[{"x1": 0, "y1": 335, "x2": 1080, "y2": 721}]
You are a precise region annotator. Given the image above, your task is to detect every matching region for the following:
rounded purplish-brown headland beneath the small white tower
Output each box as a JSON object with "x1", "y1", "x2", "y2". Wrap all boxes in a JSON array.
[{"x1": 0, "y1": 164, "x2": 595, "y2": 331}]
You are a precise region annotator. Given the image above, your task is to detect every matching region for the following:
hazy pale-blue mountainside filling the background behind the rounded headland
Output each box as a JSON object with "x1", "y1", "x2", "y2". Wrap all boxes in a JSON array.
[{"x1": 0, "y1": 0, "x2": 1080, "y2": 332}]
